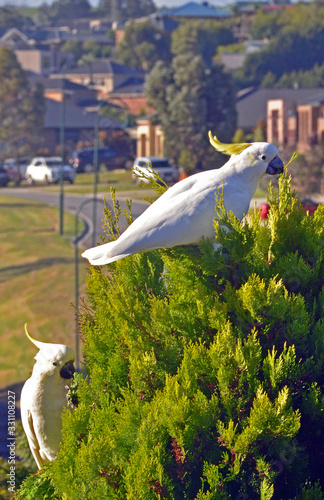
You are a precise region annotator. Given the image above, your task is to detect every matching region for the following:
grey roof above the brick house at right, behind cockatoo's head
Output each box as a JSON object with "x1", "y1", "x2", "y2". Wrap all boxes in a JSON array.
[{"x1": 236, "y1": 87, "x2": 324, "y2": 130}]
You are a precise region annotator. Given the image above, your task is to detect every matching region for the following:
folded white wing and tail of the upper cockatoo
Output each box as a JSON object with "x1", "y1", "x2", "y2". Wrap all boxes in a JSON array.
[{"x1": 82, "y1": 171, "x2": 227, "y2": 265}]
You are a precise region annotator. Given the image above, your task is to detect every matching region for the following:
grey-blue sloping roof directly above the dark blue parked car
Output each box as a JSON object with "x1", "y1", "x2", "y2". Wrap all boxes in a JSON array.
[{"x1": 44, "y1": 99, "x2": 123, "y2": 129}]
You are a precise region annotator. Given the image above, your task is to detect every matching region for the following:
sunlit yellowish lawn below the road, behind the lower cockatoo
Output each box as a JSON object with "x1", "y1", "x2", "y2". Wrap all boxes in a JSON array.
[{"x1": 0, "y1": 194, "x2": 87, "y2": 387}]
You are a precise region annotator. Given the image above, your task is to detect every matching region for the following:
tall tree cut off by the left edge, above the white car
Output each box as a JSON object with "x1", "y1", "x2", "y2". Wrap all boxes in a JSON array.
[{"x1": 0, "y1": 47, "x2": 45, "y2": 158}]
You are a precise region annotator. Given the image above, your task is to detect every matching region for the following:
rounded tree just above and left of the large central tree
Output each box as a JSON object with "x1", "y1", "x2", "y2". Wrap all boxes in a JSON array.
[{"x1": 117, "y1": 22, "x2": 171, "y2": 71}]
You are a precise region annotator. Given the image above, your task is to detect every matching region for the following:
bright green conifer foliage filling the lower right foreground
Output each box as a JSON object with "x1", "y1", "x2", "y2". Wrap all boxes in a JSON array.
[{"x1": 18, "y1": 168, "x2": 324, "y2": 500}]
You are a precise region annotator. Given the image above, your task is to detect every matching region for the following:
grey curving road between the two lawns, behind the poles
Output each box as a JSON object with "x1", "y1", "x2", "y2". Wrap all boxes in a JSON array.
[{"x1": 1, "y1": 187, "x2": 148, "y2": 247}]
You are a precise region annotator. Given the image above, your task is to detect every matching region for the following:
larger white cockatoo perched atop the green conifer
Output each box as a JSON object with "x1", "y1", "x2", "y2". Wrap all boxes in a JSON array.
[{"x1": 82, "y1": 132, "x2": 283, "y2": 266}]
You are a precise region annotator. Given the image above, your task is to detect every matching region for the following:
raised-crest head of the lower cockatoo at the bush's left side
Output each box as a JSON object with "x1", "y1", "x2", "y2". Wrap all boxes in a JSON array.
[{"x1": 25, "y1": 325, "x2": 75, "y2": 382}]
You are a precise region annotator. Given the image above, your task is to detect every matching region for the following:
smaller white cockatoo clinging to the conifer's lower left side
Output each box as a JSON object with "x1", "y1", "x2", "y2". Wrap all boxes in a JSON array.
[{"x1": 20, "y1": 325, "x2": 75, "y2": 469}]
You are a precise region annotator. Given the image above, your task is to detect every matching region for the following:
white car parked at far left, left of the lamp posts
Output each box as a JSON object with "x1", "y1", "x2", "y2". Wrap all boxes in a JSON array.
[{"x1": 26, "y1": 156, "x2": 75, "y2": 184}]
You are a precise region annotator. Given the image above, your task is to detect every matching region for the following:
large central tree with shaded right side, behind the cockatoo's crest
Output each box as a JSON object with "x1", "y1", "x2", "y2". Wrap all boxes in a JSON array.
[{"x1": 146, "y1": 53, "x2": 236, "y2": 169}]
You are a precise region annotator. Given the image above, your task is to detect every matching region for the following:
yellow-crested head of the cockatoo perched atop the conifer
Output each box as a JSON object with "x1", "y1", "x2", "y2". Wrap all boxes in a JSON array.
[{"x1": 208, "y1": 132, "x2": 283, "y2": 177}]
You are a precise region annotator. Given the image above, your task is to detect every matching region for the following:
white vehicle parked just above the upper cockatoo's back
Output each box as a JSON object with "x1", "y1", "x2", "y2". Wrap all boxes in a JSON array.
[{"x1": 133, "y1": 156, "x2": 179, "y2": 184}]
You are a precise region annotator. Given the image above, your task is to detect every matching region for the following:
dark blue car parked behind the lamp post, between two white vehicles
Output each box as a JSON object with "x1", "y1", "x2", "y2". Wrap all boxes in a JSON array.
[{"x1": 70, "y1": 147, "x2": 134, "y2": 173}]
